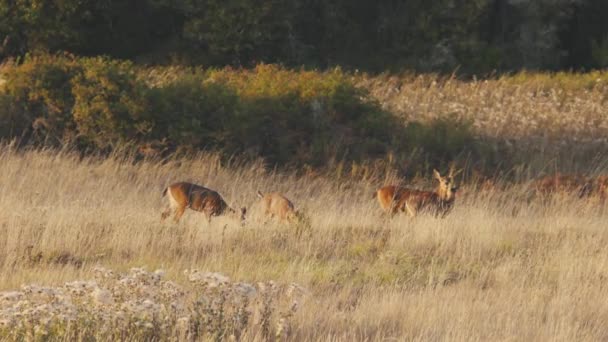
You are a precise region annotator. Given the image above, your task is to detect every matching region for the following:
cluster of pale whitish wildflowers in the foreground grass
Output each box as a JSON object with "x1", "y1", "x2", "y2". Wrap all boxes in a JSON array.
[{"x1": 0, "y1": 268, "x2": 306, "y2": 340}]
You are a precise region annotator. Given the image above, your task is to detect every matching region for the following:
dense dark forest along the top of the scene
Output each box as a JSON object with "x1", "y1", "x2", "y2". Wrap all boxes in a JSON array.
[{"x1": 0, "y1": 0, "x2": 608, "y2": 75}]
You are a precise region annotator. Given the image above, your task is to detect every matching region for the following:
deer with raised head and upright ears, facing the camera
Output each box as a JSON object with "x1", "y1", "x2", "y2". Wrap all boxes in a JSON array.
[{"x1": 376, "y1": 168, "x2": 460, "y2": 217}]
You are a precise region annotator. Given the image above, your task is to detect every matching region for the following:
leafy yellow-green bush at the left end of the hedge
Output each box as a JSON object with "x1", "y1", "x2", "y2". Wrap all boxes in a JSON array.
[{"x1": 2, "y1": 55, "x2": 153, "y2": 148}]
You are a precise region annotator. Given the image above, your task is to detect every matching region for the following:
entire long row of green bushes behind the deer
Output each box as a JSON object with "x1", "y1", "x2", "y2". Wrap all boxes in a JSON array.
[{"x1": 0, "y1": 55, "x2": 474, "y2": 172}]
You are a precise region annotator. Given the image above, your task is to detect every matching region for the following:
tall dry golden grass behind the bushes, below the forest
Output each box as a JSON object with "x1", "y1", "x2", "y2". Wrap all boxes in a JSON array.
[{"x1": 353, "y1": 72, "x2": 608, "y2": 173}]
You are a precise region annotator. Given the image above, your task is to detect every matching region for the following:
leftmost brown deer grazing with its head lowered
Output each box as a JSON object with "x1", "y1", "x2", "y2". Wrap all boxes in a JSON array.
[{"x1": 161, "y1": 182, "x2": 247, "y2": 223}]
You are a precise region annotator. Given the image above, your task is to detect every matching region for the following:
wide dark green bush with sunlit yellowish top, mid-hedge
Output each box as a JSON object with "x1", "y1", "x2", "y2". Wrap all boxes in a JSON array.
[{"x1": 143, "y1": 65, "x2": 398, "y2": 166}]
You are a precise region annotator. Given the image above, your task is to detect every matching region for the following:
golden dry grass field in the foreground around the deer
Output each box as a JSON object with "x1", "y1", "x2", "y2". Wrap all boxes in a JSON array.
[{"x1": 0, "y1": 146, "x2": 608, "y2": 341}]
